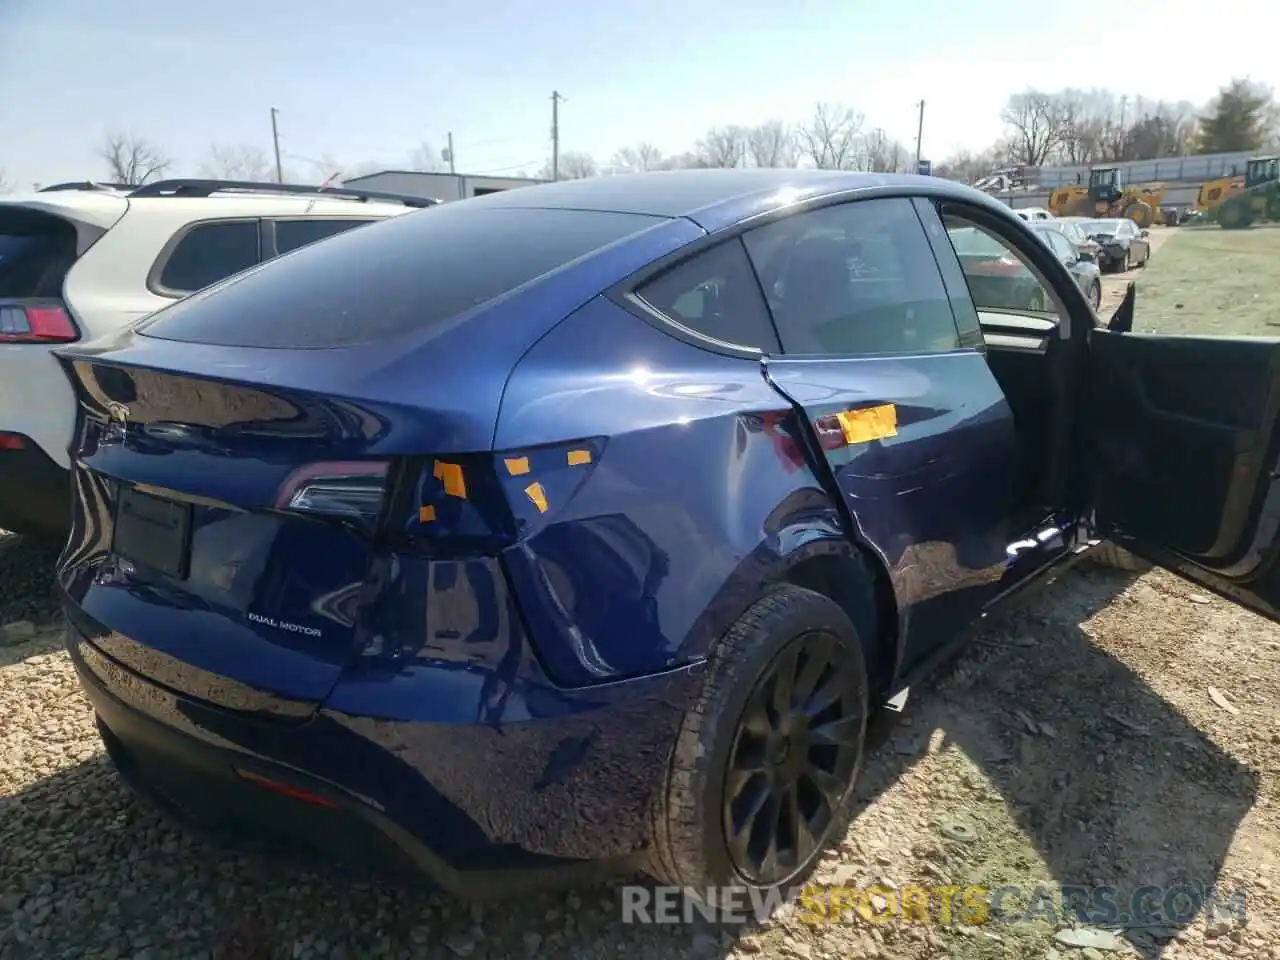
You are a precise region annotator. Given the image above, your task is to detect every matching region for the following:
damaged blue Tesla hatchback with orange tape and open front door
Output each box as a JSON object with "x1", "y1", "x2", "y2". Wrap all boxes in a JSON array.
[{"x1": 59, "y1": 170, "x2": 1280, "y2": 893}]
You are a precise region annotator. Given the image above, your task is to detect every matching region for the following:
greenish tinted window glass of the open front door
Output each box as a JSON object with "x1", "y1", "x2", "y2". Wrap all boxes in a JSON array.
[{"x1": 1133, "y1": 224, "x2": 1280, "y2": 337}]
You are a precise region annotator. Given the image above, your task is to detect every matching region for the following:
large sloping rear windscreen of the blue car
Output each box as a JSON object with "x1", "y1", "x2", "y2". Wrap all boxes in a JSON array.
[{"x1": 138, "y1": 207, "x2": 659, "y2": 348}]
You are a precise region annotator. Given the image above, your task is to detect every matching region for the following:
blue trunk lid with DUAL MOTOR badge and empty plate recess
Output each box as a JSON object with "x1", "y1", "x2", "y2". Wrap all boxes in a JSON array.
[{"x1": 60, "y1": 360, "x2": 409, "y2": 714}]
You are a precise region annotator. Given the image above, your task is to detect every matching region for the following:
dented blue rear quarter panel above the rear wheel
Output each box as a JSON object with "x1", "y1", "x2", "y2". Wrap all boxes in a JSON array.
[{"x1": 495, "y1": 297, "x2": 842, "y2": 686}]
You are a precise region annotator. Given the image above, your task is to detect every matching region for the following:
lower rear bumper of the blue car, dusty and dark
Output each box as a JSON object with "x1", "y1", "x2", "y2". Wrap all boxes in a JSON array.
[{"x1": 67, "y1": 627, "x2": 699, "y2": 896}]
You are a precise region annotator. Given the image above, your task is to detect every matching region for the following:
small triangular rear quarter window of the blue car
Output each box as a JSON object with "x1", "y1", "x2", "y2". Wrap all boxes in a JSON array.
[{"x1": 636, "y1": 239, "x2": 778, "y2": 351}]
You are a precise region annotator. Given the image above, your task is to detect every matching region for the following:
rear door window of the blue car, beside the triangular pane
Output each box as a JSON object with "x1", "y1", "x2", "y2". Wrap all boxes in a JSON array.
[{"x1": 744, "y1": 198, "x2": 961, "y2": 356}]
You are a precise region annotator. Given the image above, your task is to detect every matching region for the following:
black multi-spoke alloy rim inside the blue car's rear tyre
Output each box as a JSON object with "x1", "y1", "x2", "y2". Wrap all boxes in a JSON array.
[{"x1": 723, "y1": 631, "x2": 864, "y2": 886}]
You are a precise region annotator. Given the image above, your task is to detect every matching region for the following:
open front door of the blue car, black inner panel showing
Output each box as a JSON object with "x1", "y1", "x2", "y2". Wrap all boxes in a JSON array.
[{"x1": 1084, "y1": 308, "x2": 1280, "y2": 621}]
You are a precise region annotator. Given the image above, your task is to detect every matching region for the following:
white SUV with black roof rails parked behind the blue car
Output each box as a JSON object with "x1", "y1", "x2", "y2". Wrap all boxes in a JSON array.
[{"x1": 0, "y1": 180, "x2": 438, "y2": 539}]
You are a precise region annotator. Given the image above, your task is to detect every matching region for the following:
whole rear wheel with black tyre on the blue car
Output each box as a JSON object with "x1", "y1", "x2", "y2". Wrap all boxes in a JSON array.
[{"x1": 649, "y1": 584, "x2": 869, "y2": 910}]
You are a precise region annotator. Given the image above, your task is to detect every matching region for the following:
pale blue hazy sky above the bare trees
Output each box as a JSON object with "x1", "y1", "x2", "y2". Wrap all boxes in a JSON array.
[{"x1": 0, "y1": 0, "x2": 1280, "y2": 189}]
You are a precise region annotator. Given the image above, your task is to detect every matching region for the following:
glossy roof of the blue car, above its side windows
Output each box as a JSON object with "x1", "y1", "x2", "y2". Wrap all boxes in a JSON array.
[{"x1": 455, "y1": 168, "x2": 1007, "y2": 230}]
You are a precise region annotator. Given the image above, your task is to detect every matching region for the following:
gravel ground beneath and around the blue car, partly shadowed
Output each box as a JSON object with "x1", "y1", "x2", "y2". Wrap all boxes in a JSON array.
[{"x1": 0, "y1": 230, "x2": 1280, "y2": 960}]
